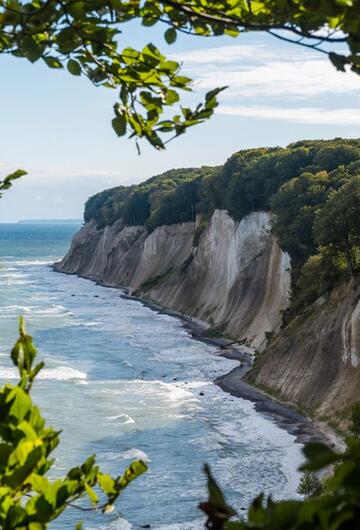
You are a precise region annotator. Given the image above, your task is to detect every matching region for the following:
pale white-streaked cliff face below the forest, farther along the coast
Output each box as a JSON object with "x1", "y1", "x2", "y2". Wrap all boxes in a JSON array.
[{"x1": 58, "y1": 210, "x2": 290, "y2": 349}]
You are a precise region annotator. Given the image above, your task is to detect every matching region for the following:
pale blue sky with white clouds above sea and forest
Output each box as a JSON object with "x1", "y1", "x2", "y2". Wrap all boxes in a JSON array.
[{"x1": 0, "y1": 24, "x2": 360, "y2": 222}]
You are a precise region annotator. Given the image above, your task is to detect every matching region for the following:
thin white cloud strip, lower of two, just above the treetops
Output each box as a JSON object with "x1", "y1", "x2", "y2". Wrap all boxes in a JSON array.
[{"x1": 218, "y1": 105, "x2": 360, "y2": 126}]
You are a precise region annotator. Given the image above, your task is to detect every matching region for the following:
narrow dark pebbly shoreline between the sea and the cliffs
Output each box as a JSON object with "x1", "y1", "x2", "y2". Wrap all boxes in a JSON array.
[{"x1": 50, "y1": 264, "x2": 345, "y2": 451}]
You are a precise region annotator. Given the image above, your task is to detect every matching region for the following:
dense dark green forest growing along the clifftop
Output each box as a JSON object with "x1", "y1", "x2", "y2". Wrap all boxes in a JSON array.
[{"x1": 85, "y1": 138, "x2": 360, "y2": 311}]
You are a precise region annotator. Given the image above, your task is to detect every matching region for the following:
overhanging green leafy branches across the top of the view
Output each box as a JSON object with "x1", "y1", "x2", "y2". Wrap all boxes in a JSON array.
[{"x1": 0, "y1": 0, "x2": 360, "y2": 149}]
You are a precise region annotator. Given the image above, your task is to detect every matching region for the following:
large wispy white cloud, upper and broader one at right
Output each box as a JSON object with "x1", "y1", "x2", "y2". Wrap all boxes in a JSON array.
[{"x1": 176, "y1": 43, "x2": 360, "y2": 99}]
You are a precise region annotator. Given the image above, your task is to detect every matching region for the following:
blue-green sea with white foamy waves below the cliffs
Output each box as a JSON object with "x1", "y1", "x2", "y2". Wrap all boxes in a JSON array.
[{"x1": 0, "y1": 224, "x2": 301, "y2": 530}]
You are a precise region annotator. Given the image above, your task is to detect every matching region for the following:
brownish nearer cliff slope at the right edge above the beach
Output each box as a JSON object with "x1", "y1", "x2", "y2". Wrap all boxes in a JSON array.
[{"x1": 247, "y1": 279, "x2": 360, "y2": 427}]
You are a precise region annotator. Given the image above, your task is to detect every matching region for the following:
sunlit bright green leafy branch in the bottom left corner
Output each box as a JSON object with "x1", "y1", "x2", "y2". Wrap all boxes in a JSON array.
[{"x1": 0, "y1": 318, "x2": 147, "y2": 530}]
